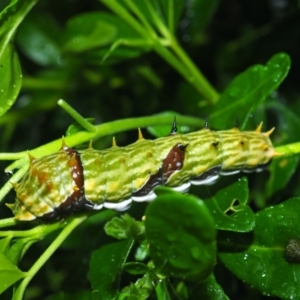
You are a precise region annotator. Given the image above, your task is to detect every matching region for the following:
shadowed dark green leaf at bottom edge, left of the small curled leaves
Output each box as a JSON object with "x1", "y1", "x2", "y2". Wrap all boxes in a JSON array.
[{"x1": 90, "y1": 240, "x2": 133, "y2": 300}]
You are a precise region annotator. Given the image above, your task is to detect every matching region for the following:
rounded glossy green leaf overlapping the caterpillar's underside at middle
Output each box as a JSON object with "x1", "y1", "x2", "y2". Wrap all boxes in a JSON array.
[{"x1": 145, "y1": 189, "x2": 216, "y2": 280}]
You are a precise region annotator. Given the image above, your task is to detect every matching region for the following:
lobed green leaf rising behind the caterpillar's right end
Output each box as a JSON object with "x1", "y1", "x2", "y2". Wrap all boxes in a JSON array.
[{"x1": 210, "y1": 53, "x2": 291, "y2": 128}]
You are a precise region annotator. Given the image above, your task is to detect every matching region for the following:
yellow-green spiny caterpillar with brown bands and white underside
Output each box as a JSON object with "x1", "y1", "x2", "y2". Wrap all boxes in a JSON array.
[{"x1": 6, "y1": 120, "x2": 279, "y2": 221}]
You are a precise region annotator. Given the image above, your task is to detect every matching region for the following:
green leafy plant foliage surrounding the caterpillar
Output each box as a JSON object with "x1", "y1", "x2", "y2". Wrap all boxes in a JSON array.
[{"x1": 0, "y1": 0, "x2": 300, "y2": 300}]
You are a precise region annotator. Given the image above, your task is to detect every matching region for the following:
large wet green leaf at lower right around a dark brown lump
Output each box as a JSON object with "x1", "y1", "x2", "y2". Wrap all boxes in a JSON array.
[{"x1": 218, "y1": 198, "x2": 300, "y2": 299}]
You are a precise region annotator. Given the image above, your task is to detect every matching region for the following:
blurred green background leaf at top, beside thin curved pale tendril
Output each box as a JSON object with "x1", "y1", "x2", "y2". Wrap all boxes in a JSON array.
[{"x1": 63, "y1": 12, "x2": 148, "y2": 63}]
